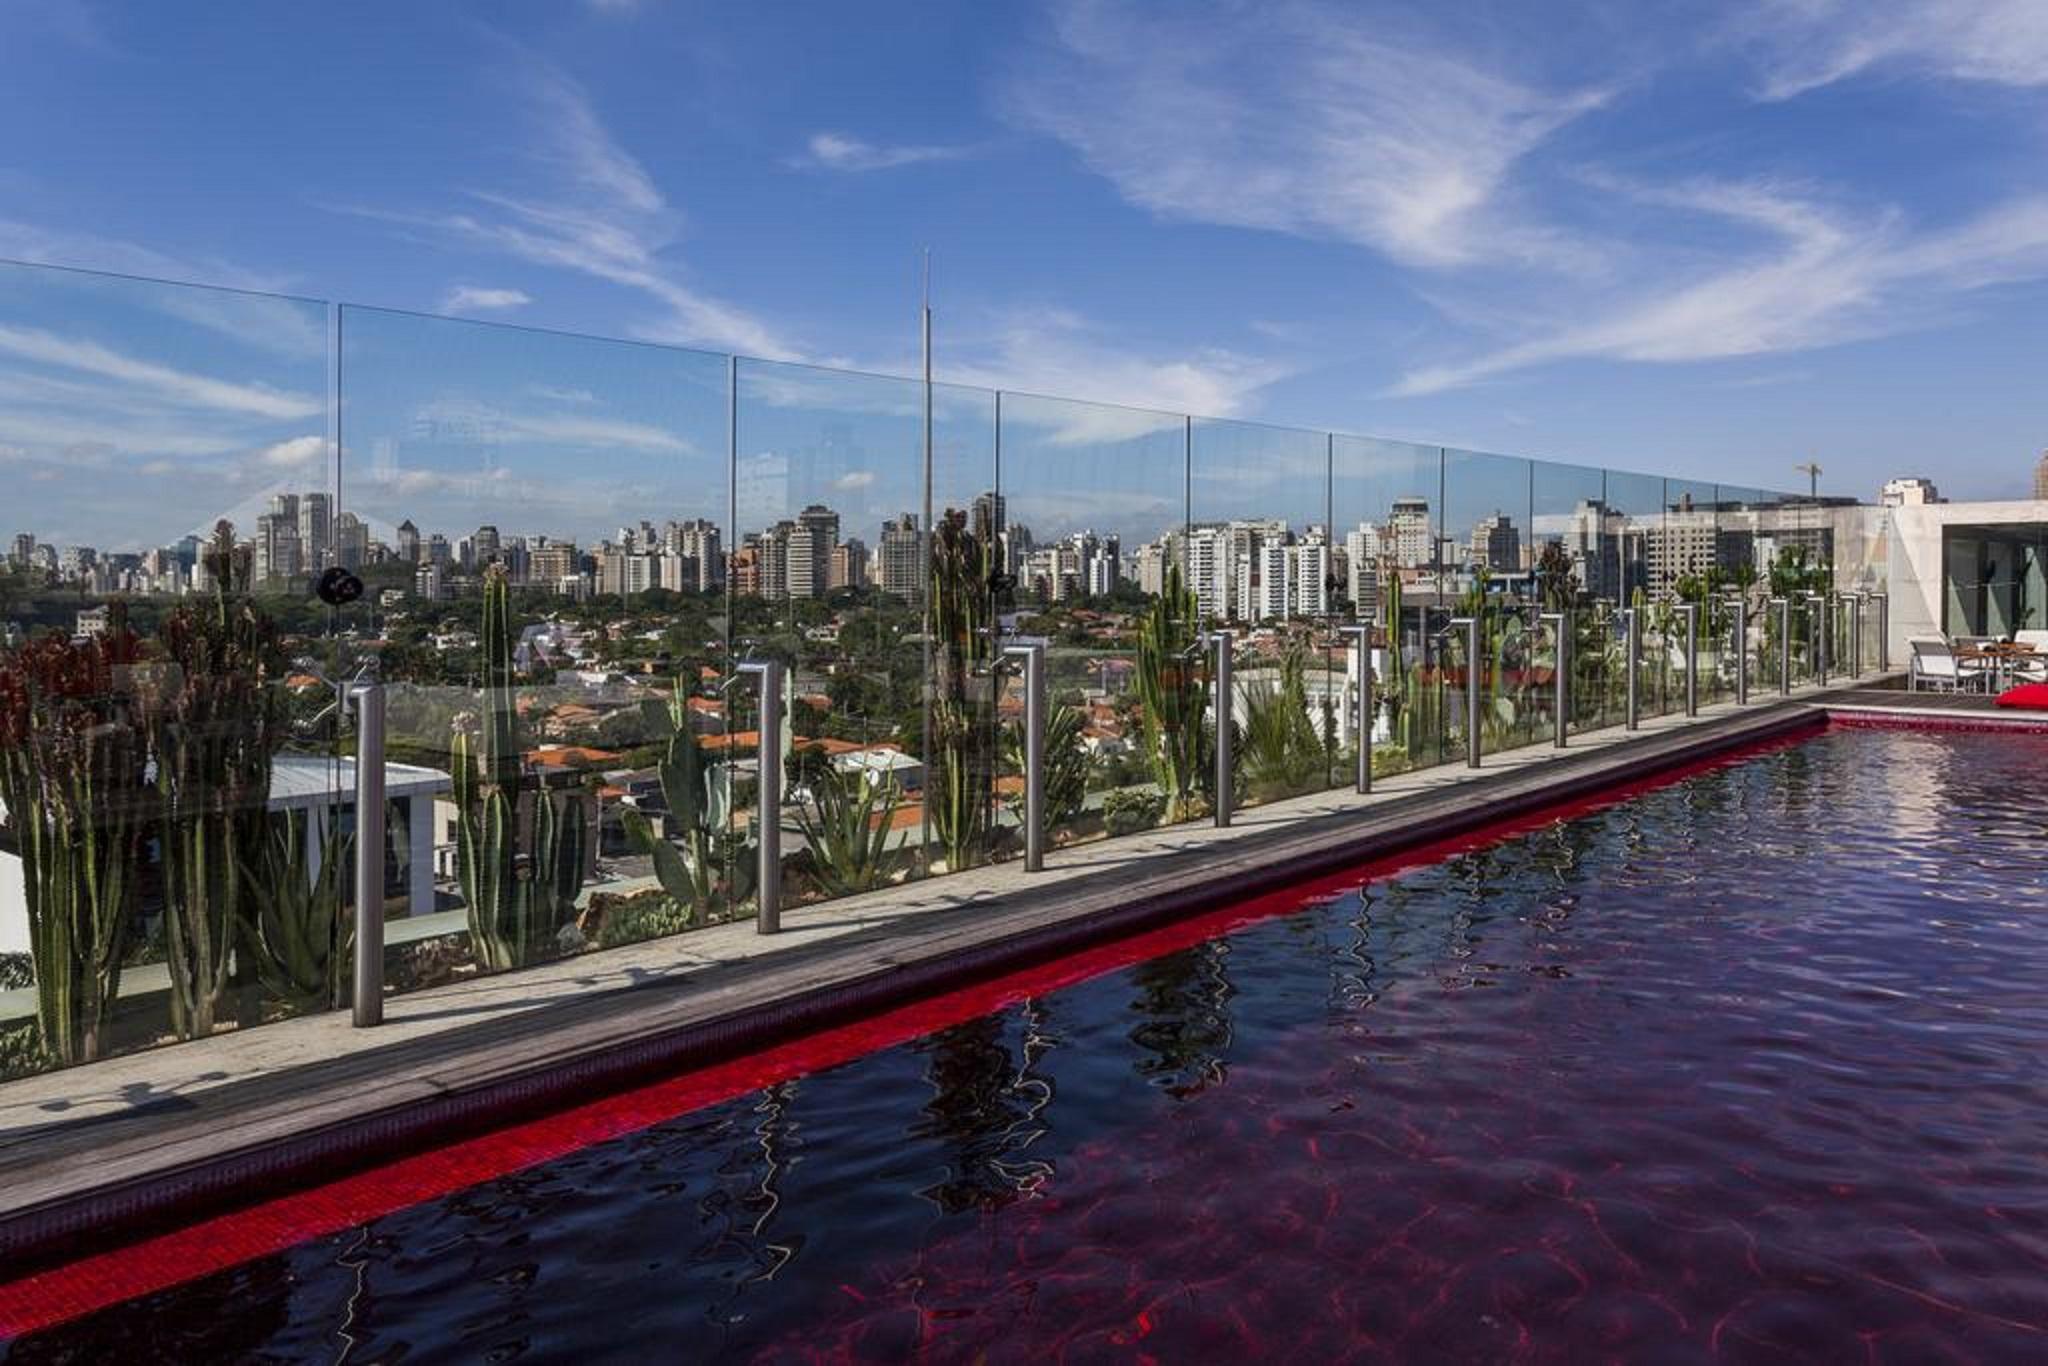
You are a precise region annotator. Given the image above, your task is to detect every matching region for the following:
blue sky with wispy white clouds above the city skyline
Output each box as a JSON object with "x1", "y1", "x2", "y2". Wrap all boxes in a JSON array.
[{"x1": 0, "y1": 0, "x2": 2048, "y2": 548}]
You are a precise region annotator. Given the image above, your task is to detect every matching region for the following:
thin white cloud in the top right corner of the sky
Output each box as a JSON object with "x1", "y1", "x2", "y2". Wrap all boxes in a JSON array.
[{"x1": 1745, "y1": 0, "x2": 2048, "y2": 100}]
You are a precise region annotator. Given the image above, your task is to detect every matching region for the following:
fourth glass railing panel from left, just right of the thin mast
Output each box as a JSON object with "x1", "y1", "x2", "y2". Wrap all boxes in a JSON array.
[{"x1": 999, "y1": 393, "x2": 1214, "y2": 842}]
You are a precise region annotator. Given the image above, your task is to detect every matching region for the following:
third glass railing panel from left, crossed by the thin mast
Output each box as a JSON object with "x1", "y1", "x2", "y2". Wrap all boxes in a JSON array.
[{"x1": 731, "y1": 360, "x2": 962, "y2": 909}]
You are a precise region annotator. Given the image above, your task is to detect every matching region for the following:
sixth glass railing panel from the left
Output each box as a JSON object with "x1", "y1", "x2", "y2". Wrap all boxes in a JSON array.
[{"x1": 1331, "y1": 436, "x2": 1450, "y2": 774}]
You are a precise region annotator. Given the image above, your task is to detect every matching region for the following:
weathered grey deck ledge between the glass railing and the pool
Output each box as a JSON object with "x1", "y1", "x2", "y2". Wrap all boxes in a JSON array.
[{"x1": 0, "y1": 678, "x2": 1875, "y2": 1270}]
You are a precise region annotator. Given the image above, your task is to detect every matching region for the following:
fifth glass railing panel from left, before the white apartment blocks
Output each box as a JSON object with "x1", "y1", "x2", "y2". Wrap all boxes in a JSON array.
[{"x1": 1188, "y1": 420, "x2": 1346, "y2": 805}]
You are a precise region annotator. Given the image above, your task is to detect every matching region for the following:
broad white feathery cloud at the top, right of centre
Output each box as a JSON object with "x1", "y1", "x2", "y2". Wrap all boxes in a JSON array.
[{"x1": 1008, "y1": 2, "x2": 1606, "y2": 268}]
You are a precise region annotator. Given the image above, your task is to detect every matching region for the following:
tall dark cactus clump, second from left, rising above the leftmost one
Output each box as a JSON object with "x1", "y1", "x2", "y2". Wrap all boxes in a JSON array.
[{"x1": 150, "y1": 522, "x2": 285, "y2": 1038}]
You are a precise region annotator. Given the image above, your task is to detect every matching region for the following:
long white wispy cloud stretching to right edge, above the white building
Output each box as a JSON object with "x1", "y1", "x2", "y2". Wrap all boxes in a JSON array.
[{"x1": 1393, "y1": 182, "x2": 2048, "y2": 395}]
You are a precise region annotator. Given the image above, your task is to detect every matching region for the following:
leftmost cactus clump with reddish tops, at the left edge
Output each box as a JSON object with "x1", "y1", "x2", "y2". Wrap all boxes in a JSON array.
[{"x1": 0, "y1": 621, "x2": 154, "y2": 1063}]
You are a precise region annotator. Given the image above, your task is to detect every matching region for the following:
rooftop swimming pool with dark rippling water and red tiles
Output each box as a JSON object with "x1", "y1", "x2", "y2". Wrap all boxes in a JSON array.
[{"x1": 0, "y1": 729, "x2": 2048, "y2": 1362}]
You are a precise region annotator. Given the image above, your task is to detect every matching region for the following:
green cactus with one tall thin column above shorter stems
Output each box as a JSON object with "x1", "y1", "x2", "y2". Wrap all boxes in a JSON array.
[{"x1": 451, "y1": 565, "x2": 590, "y2": 971}]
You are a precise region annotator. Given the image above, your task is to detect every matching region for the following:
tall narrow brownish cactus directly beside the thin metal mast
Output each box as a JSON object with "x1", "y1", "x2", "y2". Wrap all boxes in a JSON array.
[{"x1": 924, "y1": 512, "x2": 995, "y2": 872}]
